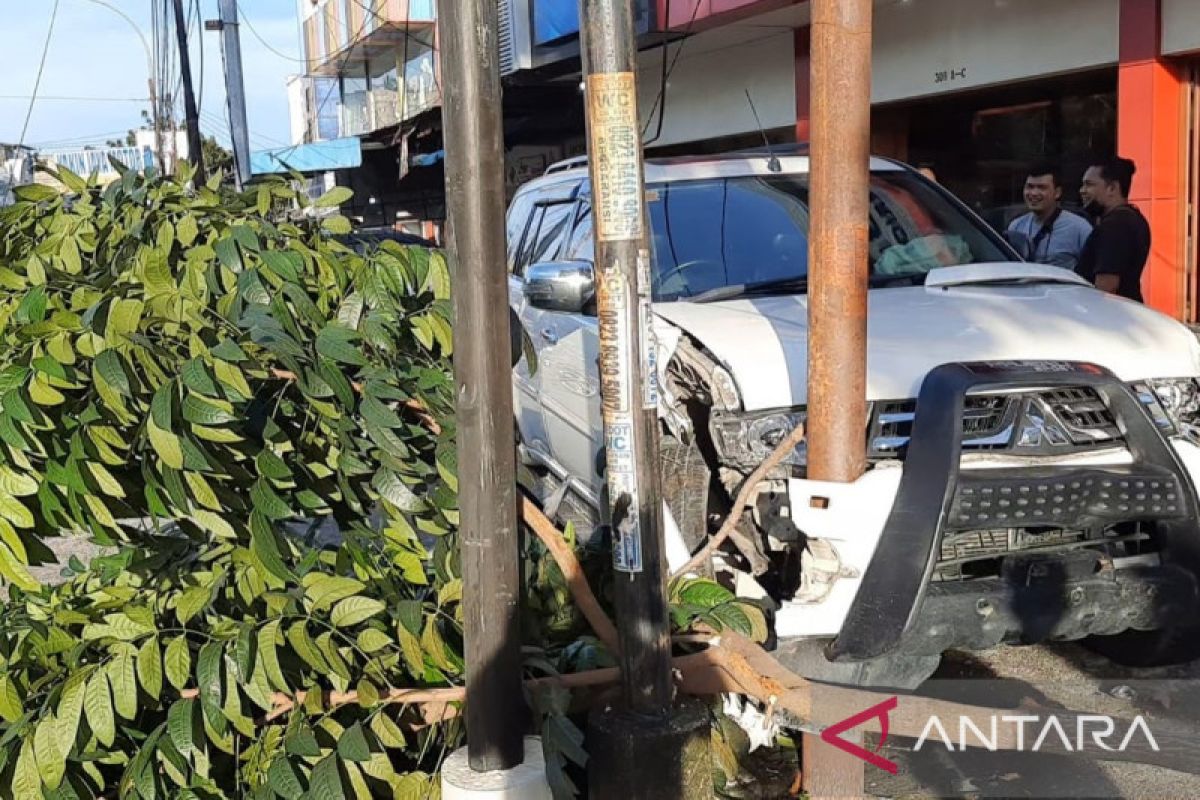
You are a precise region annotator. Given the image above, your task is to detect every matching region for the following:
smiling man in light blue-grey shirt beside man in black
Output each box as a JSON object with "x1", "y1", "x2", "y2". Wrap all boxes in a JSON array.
[{"x1": 1008, "y1": 164, "x2": 1092, "y2": 270}]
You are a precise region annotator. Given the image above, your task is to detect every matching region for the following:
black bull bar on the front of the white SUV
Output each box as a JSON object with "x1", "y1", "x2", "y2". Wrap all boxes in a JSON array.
[{"x1": 828, "y1": 361, "x2": 1200, "y2": 661}]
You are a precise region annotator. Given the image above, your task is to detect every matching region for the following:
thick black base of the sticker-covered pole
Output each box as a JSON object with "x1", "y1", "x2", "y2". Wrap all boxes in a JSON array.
[{"x1": 587, "y1": 698, "x2": 713, "y2": 800}]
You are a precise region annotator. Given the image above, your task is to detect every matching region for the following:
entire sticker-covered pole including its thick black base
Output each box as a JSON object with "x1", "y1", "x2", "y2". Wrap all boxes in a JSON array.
[{"x1": 580, "y1": 0, "x2": 712, "y2": 800}]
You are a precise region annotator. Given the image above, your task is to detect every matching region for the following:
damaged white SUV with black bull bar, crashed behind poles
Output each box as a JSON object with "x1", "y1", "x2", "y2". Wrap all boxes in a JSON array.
[{"x1": 508, "y1": 154, "x2": 1200, "y2": 687}]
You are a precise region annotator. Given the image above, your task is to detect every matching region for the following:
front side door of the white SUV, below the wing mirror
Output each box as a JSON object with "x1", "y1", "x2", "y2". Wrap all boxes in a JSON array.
[{"x1": 541, "y1": 200, "x2": 604, "y2": 498}]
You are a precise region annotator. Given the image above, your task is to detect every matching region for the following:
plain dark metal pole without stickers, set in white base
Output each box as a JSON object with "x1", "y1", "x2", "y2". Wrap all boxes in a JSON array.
[{"x1": 438, "y1": 0, "x2": 526, "y2": 771}]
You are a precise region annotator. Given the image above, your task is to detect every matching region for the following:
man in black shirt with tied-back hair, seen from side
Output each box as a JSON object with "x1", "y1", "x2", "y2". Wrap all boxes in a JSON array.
[{"x1": 1075, "y1": 158, "x2": 1150, "y2": 302}]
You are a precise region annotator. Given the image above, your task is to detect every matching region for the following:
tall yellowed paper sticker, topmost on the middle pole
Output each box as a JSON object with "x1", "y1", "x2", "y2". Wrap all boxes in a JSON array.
[{"x1": 587, "y1": 72, "x2": 642, "y2": 241}]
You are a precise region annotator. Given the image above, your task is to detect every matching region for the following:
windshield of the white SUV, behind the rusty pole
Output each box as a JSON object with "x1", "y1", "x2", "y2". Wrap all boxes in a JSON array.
[{"x1": 647, "y1": 170, "x2": 1012, "y2": 300}]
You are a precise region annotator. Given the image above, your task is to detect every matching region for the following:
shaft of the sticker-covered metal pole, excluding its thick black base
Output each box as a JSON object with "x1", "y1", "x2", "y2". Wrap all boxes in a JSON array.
[{"x1": 580, "y1": 0, "x2": 673, "y2": 716}]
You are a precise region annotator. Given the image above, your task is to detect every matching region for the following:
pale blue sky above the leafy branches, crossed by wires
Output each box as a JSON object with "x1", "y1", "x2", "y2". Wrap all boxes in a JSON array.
[{"x1": 0, "y1": 0, "x2": 304, "y2": 150}]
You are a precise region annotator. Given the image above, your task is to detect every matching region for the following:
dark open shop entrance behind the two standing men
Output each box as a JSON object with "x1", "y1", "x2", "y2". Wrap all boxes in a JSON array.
[{"x1": 871, "y1": 68, "x2": 1117, "y2": 235}]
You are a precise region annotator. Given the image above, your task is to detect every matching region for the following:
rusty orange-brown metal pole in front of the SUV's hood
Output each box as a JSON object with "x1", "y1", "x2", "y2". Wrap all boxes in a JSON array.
[{"x1": 803, "y1": 0, "x2": 872, "y2": 798}]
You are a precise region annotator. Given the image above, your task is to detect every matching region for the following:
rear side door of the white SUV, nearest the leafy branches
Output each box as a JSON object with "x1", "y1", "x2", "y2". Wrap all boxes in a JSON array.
[{"x1": 509, "y1": 185, "x2": 574, "y2": 458}]
